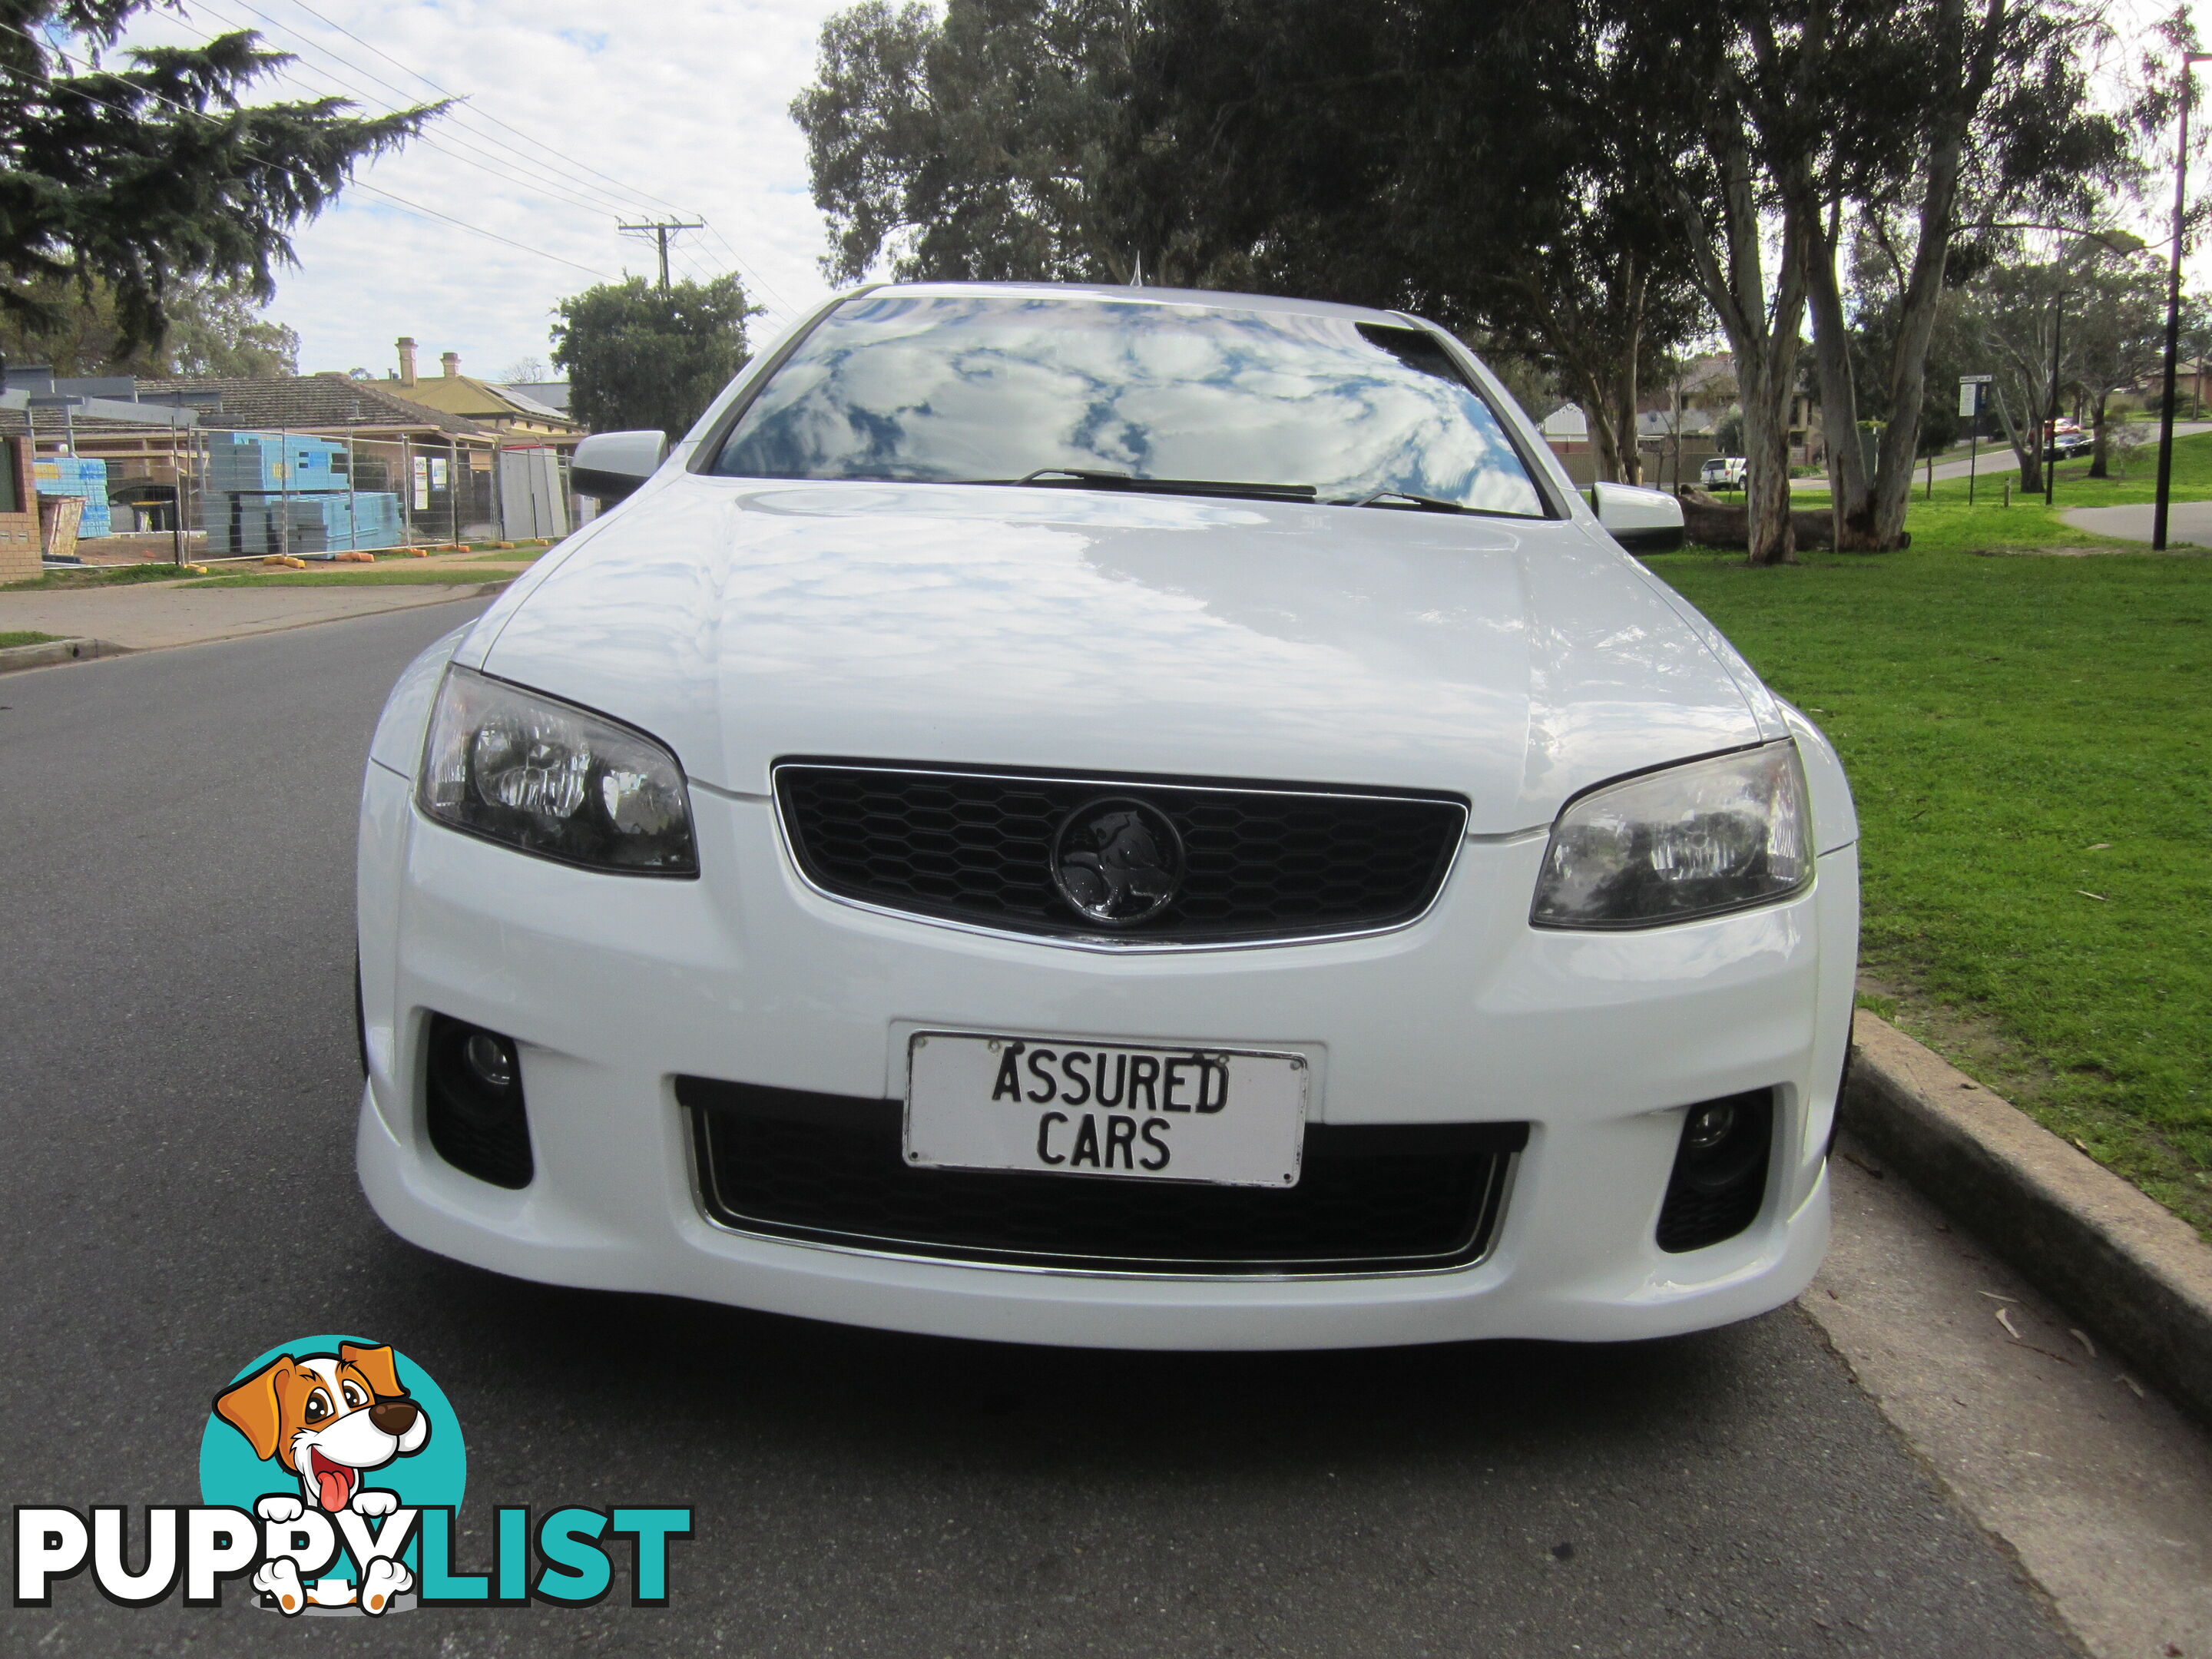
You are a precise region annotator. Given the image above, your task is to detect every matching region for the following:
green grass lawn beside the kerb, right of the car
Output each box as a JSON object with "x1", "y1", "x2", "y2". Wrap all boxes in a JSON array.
[{"x1": 1648, "y1": 433, "x2": 2212, "y2": 1237}]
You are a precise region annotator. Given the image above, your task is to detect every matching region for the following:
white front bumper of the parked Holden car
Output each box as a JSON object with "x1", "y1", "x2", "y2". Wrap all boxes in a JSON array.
[{"x1": 359, "y1": 765, "x2": 1858, "y2": 1349}]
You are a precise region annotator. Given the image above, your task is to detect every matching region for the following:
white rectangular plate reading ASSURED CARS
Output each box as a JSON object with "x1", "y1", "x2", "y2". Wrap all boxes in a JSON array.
[{"x1": 905, "y1": 1031, "x2": 1310, "y2": 1186}]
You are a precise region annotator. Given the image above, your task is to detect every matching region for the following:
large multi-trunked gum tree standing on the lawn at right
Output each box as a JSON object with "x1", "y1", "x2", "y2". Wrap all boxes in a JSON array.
[{"x1": 1588, "y1": 0, "x2": 2166, "y2": 564}]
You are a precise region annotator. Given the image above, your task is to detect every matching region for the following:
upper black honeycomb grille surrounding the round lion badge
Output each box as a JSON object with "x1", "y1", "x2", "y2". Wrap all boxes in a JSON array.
[{"x1": 777, "y1": 761, "x2": 1466, "y2": 942}]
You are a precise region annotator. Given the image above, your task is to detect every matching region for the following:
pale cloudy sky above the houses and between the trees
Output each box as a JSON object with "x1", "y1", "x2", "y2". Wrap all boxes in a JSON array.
[{"x1": 104, "y1": 0, "x2": 2212, "y2": 378}]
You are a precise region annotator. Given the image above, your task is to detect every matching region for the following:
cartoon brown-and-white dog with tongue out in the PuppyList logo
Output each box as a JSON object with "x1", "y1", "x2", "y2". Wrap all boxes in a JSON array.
[{"x1": 214, "y1": 1343, "x2": 429, "y2": 1614}]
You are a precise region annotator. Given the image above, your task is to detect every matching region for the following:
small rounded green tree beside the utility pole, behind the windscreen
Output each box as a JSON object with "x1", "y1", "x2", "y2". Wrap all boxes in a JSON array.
[{"x1": 553, "y1": 276, "x2": 761, "y2": 438}]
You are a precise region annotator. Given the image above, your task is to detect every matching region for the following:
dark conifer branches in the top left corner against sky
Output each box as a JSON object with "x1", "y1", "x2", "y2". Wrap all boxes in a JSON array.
[{"x1": 0, "y1": 0, "x2": 445, "y2": 359}]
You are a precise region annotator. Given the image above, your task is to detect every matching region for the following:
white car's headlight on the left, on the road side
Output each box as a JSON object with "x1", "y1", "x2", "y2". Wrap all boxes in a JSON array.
[{"x1": 416, "y1": 668, "x2": 699, "y2": 876}]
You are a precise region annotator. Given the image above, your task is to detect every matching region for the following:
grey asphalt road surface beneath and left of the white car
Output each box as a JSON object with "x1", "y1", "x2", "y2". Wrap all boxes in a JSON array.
[{"x1": 0, "y1": 606, "x2": 2073, "y2": 1659}]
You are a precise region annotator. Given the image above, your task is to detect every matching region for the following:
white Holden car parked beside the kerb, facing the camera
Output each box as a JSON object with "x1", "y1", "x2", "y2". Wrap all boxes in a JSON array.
[{"x1": 359, "y1": 283, "x2": 1858, "y2": 1347}]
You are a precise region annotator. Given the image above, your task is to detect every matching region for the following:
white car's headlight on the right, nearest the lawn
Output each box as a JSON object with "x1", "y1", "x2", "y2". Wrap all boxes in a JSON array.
[{"x1": 1528, "y1": 739, "x2": 1812, "y2": 927}]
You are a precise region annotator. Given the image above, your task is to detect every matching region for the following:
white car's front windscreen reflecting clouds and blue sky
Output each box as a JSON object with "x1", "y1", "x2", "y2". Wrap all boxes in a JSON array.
[{"x1": 712, "y1": 294, "x2": 1548, "y2": 518}]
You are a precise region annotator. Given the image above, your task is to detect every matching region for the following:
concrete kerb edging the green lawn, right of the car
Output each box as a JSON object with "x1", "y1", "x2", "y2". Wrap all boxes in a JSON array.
[{"x1": 1843, "y1": 1011, "x2": 2212, "y2": 1422}]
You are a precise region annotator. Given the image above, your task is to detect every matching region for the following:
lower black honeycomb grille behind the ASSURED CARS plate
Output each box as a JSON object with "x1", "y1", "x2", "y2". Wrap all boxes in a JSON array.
[{"x1": 677, "y1": 1078, "x2": 1528, "y2": 1274}]
